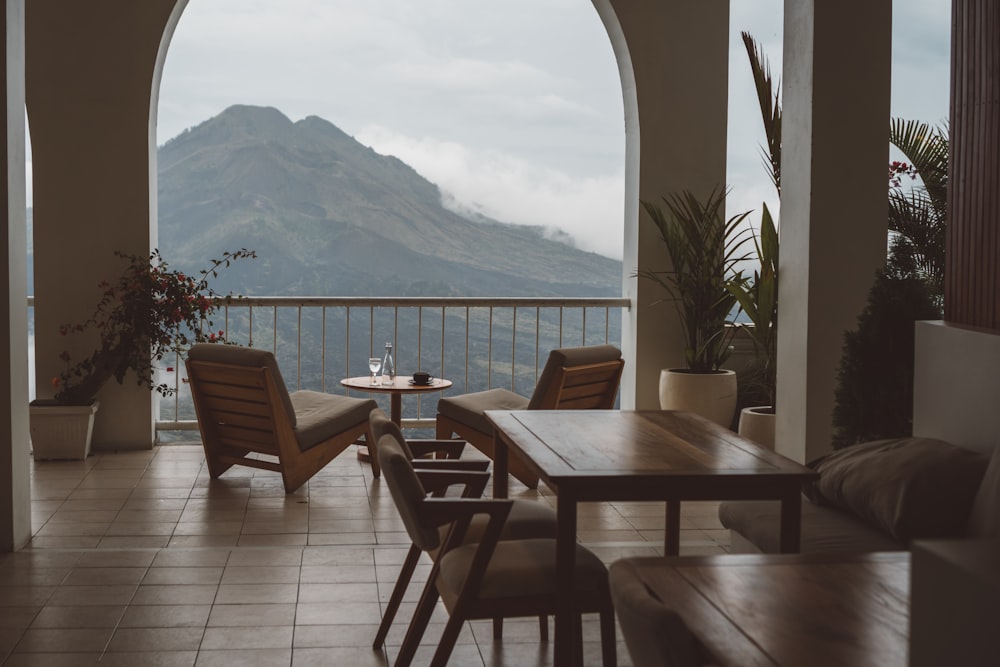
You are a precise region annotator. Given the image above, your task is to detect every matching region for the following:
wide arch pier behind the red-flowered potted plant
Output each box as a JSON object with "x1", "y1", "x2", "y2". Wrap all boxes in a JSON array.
[{"x1": 26, "y1": 0, "x2": 183, "y2": 449}]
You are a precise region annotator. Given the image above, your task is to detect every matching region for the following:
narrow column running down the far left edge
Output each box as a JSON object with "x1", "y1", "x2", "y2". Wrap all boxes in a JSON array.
[{"x1": 0, "y1": 0, "x2": 31, "y2": 553}]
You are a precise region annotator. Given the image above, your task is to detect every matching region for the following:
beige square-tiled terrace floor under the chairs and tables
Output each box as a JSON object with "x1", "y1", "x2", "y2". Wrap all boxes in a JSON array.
[{"x1": 0, "y1": 445, "x2": 728, "y2": 667}]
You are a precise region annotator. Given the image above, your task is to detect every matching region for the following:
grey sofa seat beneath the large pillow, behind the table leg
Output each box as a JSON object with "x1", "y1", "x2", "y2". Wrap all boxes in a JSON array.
[{"x1": 719, "y1": 498, "x2": 906, "y2": 553}]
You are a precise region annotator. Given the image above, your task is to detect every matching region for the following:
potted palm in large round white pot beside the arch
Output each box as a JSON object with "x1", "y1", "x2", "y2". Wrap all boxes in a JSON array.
[{"x1": 636, "y1": 188, "x2": 748, "y2": 427}]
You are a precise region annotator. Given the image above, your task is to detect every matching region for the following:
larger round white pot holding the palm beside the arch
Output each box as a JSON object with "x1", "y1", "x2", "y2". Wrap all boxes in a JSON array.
[{"x1": 660, "y1": 368, "x2": 736, "y2": 428}]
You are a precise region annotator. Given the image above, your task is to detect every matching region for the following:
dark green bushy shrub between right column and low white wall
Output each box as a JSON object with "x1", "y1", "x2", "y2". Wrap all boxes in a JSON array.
[{"x1": 833, "y1": 273, "x2": 938, "y2": 449}]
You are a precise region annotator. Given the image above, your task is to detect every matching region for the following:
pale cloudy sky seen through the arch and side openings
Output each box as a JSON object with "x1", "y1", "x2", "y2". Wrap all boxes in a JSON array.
[{"x1": 157, "y1": 0, "x2": 950, "y2": 258}]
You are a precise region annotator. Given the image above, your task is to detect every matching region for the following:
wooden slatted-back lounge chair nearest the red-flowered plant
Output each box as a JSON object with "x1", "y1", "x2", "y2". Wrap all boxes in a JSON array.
[{"x1": 186, "y1": 343, "x2": 379, "y2": 493}]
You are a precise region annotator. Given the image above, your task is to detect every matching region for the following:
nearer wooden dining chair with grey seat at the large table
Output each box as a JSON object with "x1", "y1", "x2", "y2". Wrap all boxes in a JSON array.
[{"x1": 376, "y1": 422, "x2": 616, "y2": 667}]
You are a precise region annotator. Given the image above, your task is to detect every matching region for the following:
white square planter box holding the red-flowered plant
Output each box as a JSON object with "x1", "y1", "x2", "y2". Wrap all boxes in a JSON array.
[{"x1": 29, "y1": 401, "x2": 101, "y2": 460}]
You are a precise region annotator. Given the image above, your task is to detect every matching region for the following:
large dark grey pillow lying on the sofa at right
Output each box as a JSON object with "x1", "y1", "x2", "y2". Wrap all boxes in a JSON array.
[{"x1": 806, "y1": 438, "x2": 989, "y2": 543}]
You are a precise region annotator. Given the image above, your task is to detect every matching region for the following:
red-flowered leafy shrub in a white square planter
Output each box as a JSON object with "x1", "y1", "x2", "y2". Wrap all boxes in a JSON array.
[{"x1": 30, "y1": 248, "x2": 256, "y2": 459}]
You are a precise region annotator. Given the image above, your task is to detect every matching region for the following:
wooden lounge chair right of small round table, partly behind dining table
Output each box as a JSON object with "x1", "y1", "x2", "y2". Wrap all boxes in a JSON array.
[{"x1": 436, "y1": 345, "x2": 625, "y2": 489}]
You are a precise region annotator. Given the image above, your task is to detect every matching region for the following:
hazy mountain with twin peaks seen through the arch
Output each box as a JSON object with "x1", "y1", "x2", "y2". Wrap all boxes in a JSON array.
[{"x1": 159, "y1": 106, "x2": 622, "y2": 296}]
